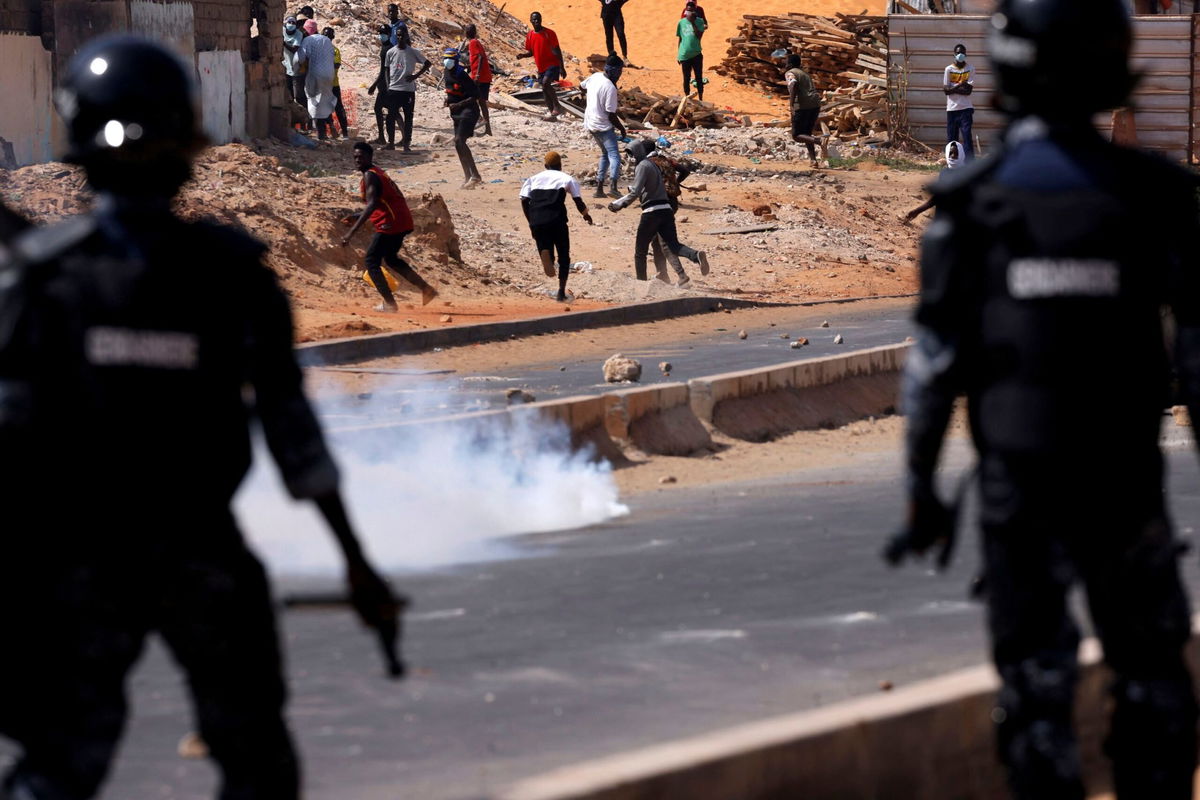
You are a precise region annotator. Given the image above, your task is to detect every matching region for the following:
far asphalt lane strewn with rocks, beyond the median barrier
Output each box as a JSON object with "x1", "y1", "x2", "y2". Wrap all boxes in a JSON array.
[{"x1": 309, "y1": 303, "x2": 913, "y2": 429}]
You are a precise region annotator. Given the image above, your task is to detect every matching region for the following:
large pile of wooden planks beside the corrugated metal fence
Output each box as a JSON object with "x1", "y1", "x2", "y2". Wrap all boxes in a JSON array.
[{"x1": 716, "y1": 12, "x2": 888, "y2": 144}]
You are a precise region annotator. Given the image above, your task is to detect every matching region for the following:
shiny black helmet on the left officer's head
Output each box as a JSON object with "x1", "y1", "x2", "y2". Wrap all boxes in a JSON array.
[{"x1": 54, "y1": 35, "x2": 205, "y2": 194}]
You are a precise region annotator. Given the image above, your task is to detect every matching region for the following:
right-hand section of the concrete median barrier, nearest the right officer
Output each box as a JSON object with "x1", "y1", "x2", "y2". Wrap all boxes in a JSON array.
[{"x1": 688, "y1": 344, "x2": 911, "y2": 441}]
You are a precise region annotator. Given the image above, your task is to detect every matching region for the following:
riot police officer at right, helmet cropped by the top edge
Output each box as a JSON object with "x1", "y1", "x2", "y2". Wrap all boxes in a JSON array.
[{"x1": 888, "y1": 0, "x2": 1200, "y2": 800}]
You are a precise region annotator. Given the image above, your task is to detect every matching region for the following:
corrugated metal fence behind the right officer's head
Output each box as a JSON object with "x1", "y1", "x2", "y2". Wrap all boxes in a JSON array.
[{"x1": 888, "y1": 14, "x2": 1200, "y2": 161}]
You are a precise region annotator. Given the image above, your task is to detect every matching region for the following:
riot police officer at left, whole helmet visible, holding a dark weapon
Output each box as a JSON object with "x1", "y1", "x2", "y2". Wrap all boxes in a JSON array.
[{"x1": 0, "y1": 36, "x2": 400, "y2": 800}]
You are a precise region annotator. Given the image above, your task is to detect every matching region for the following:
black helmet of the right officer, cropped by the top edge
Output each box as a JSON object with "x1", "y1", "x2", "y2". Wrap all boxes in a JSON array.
[{"x1": 988, "y1": 0, "x2": 1136, "y2": 118}]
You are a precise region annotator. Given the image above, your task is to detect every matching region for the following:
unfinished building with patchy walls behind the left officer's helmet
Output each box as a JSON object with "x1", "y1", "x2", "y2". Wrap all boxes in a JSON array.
[{"x1": 0, "y1": 0, "x2": 287, "y2": 168}]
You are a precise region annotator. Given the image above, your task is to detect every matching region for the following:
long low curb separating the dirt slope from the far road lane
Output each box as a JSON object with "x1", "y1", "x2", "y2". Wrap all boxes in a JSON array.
[{"x1": 295, "y1": 295, "x2": 916, "y2": 367}]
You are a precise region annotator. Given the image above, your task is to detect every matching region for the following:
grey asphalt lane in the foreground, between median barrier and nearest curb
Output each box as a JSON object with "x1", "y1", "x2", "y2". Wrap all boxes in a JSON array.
[{"x1": 2, "y1": 445, "x2": 1200, "y2": 800}]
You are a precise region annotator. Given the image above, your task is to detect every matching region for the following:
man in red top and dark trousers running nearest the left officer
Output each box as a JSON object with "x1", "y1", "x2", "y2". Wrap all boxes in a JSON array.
[{"x1": 342, "y1": 142, "x2": 438, "y2": 313}]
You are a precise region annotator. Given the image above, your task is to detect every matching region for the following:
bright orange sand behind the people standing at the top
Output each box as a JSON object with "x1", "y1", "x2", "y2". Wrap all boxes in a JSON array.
[{"x1": 501, "y1": 0, "x2": 887, "y2": 119}]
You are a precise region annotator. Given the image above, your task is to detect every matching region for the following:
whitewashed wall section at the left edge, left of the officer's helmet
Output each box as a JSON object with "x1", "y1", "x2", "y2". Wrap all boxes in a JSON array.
[{"x1": 0, "y1": 34, "x2": 54, "y2": 167}]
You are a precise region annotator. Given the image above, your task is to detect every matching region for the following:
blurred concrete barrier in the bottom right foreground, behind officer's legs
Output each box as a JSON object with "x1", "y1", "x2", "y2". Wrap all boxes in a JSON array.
[{"x1": 493, "y1": 638, "x2": 1171, "y2": 800}]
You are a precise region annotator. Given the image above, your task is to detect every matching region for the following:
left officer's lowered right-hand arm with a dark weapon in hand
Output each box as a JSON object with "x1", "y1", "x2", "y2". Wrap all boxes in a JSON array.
[{"x1": 247, "y1": 266, "x2": 403, "y2": 676}]
